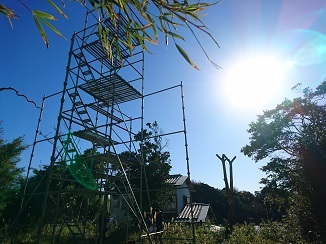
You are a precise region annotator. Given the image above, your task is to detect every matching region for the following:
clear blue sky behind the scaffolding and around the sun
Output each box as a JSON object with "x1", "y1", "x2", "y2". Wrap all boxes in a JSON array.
[{"x1": 0, "y1": 0, "x2": 326, "y2": 192}]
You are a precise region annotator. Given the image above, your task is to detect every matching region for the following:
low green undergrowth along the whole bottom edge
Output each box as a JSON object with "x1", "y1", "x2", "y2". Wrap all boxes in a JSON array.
[{"x1": 3, "y1": 221, "x2": 310, "y2": 244}]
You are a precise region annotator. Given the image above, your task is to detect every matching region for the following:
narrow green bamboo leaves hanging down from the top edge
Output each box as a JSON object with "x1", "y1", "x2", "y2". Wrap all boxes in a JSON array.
[{"x1": 0, "y1": 0, "x2": 219, "y2": 69}]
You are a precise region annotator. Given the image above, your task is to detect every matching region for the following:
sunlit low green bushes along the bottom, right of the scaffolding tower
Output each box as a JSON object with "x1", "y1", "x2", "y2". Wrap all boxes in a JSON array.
[{"x1": 130, "y1": 222, "x2": 311, "y2": 244}]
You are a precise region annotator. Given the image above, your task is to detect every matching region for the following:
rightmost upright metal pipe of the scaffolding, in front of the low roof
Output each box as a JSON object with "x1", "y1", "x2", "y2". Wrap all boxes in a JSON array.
[{"x1": 180, "y1": 81, "x2": 196, "y2": 243}]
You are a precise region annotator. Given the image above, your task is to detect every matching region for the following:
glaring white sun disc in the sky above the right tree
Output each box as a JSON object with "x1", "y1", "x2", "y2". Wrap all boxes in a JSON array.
[{"x1": 223, "y1": 56, "x2": 285, "y2": 109}]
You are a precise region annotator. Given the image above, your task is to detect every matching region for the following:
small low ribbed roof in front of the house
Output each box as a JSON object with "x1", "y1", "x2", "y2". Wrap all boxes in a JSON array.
[{"x1": 176, "y1": 203, "x2": 210, "y2": 222}]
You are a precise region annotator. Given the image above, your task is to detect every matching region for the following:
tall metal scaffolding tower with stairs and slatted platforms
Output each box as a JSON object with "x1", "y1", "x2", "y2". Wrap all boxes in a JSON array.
[{"x1": 7, "y1": 7, "x2": 194, "y2": 243}]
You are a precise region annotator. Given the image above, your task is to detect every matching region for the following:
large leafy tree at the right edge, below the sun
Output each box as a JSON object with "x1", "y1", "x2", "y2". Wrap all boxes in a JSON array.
[{"x1": 241, "y1": 82, "x2": 326, "y2": 242}]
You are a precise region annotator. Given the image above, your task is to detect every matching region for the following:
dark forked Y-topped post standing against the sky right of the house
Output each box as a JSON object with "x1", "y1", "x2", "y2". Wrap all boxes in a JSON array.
[{"x1": 216, "y1": 154, "x2": 236, "y2": 234}]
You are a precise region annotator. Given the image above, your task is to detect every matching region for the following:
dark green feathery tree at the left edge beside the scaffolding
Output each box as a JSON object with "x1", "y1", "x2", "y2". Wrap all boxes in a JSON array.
[{"x1": 0, "y1": 128, "x2": 27, "y2": 213}]
